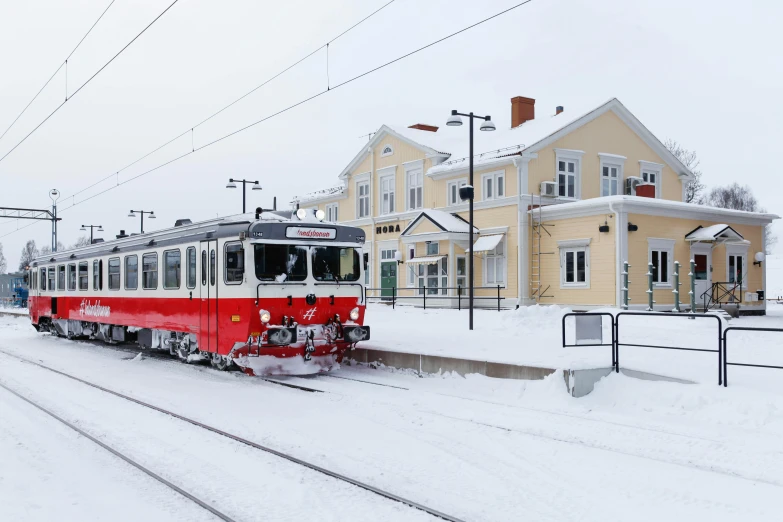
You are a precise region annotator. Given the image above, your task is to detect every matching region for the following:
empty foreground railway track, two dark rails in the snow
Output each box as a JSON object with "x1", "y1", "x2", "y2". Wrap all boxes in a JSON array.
[{"x1": 0, "y1": 350, "x2": 465, "y2": 522}]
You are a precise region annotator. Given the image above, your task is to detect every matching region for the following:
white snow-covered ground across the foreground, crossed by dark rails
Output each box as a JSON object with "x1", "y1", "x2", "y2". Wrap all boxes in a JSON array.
[{"x1": 0, "y1": 310, "x2": 783, "y2": 522}]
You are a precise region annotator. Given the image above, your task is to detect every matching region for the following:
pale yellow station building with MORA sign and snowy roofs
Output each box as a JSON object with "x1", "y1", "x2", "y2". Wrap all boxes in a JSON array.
[{"x1": 293, "y1": 96, "x2": 778, "y2": 313}]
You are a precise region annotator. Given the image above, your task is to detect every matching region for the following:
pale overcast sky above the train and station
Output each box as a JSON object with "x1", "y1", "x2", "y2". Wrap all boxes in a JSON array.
[{"x1": 0, "y1": 0, "x2": 783, "y2": 269}]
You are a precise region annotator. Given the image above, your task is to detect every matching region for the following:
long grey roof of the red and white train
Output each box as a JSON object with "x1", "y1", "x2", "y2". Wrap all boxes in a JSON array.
[{"x1": 32, "y1": 210, "x2": 365, "y2": 266}]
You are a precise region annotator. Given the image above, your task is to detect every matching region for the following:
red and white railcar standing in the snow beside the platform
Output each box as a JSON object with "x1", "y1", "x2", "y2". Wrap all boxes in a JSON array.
[{"x1": 29, "y1": 209, "x2": 370, "y2": 375}]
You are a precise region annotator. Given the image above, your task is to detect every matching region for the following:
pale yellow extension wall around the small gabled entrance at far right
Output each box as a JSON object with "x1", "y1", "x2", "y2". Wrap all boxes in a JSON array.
[{"x1": 628, "y1": 214, "x2": 764, "y2": 305}]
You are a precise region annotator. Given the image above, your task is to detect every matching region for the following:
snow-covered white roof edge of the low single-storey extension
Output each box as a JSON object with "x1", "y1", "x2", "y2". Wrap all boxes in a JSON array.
[{"x1": 530, "y1": 196, "x2": 780, "y2": 222}]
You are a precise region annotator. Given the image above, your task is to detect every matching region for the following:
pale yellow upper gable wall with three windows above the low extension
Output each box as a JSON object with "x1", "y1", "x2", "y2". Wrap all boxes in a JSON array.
[{"x1": 528, "y1": 111, "x2": 682, "y2": 201}]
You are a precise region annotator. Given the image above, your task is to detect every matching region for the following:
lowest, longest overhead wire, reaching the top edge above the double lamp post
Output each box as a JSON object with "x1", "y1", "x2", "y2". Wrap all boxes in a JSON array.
[{"x1": 0, "y1": 0, "x2": 533, "y2": 238}]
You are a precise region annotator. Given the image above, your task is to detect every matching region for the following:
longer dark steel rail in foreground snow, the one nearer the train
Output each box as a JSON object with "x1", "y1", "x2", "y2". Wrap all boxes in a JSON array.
[{"x1": 0, "y1": 350, "x2": 465, "y2": 522}]
